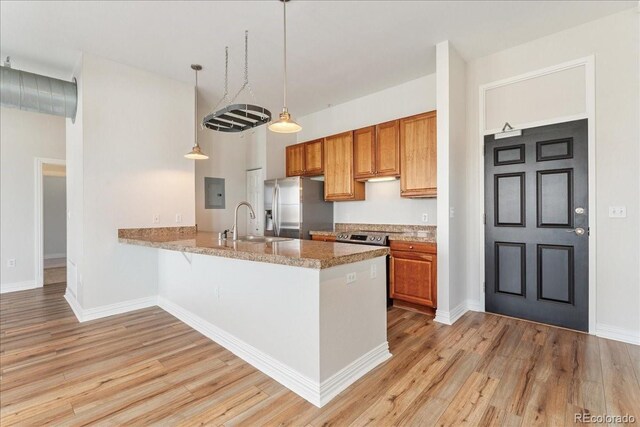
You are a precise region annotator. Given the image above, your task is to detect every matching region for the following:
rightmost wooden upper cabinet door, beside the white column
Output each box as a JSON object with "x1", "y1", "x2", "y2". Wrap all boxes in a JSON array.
[{"x1": 400, "y1": 111, "x2": 437, "y2": 197}]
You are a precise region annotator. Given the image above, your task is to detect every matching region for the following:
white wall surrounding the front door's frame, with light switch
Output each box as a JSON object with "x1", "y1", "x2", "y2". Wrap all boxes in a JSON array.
[{"x1": 465, "y1": 10, "x2": 640, "y2": 342}]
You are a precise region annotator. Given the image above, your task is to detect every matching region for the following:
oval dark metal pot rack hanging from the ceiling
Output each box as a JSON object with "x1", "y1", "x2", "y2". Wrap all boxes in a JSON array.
[{"x1": 202, "y1": 31, "x2": 271, "y2": 132}]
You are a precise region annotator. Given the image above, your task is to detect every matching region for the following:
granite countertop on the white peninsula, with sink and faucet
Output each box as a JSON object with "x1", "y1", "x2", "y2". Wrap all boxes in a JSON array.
[{"x1": 118, "y1": 227, "x2": 389, "y2": 269}]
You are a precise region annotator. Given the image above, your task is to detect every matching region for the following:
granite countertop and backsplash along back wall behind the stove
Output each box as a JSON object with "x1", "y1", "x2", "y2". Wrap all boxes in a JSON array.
[{"x1": 310, "y1": 223, "x2": 436, "y2": 243}]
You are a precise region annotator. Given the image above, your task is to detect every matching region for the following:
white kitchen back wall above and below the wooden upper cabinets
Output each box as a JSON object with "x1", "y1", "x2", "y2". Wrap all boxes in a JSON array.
[{"x1": 296, "y1": 74, "x2": 437, "y2": 224}]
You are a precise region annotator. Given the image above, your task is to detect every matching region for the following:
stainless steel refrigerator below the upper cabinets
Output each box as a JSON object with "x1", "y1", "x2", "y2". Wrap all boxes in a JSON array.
[{"x1": 264, "y1": 177, "x2": 333, "y2": 239}]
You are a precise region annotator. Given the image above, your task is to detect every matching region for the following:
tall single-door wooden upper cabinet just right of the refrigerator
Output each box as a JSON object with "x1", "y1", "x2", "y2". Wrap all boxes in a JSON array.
[{"x1": 324, "y1": 132, "x2": 364, "y2": 201}]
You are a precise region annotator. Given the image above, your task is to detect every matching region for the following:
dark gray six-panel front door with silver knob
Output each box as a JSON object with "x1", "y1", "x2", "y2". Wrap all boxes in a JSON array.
[{"x1": 484, "y1": 120, "x2": 589, "y2": 331}]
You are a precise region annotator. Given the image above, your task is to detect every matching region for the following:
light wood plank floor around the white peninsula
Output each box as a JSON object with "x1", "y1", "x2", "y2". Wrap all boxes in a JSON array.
[{"x1": 0, "y1": 285, "x2": 640, "y2": 427}]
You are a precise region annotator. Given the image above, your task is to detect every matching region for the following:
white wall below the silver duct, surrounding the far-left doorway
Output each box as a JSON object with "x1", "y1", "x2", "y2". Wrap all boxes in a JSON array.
[{"x1": 0, "y1": 108, "x2": 65, "y2": 287}]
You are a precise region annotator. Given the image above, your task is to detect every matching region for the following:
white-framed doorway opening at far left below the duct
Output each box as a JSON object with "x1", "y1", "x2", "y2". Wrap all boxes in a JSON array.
[{"x1": 35, "y1": 159, "x2": 67, "y2": 286}]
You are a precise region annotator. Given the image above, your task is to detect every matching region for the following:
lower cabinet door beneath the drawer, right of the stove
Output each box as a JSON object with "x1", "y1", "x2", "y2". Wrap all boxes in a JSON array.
[{"x1": 390, "y1": 251, "x2": 437, "y2": 308}]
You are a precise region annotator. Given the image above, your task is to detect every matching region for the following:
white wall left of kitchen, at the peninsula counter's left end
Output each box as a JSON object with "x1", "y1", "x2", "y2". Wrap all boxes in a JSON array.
[{"x1": 67, "y1": 55, "x2": 195, "y2": 309}]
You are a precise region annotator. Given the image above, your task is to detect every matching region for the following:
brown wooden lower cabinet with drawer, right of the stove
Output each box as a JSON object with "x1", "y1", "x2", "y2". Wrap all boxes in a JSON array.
[{"x1": 389, "y1": 241, "x2": 438, "y2": 309}]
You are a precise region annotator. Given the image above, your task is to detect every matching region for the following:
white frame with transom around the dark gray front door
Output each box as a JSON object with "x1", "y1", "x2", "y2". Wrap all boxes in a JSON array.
[{"x1": 478, "y1": 55, "x2": 597, "y2": 334}]
